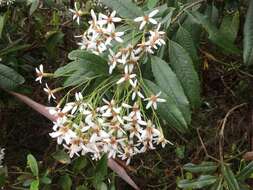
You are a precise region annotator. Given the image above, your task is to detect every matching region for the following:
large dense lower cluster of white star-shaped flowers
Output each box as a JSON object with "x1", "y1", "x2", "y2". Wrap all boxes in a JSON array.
[{"x1": 49, "y1": 93, "x2": 172, "y2": 164}]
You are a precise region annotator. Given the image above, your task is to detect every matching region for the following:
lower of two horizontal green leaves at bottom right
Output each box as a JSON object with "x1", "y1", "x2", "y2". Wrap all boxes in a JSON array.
[{"x1": 177, "y1": 175, "x2": 217, "y2": 189}]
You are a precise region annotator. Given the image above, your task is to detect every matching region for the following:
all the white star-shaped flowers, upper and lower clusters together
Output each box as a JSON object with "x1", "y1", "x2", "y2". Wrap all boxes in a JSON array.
[{"x1": 36, "y1": 4, "x2": 170, "y2": 164}]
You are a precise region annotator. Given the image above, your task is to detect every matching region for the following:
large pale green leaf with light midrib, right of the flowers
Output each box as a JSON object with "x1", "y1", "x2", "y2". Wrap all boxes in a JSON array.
[{"x1": 151, "y1": 56, "x2": 191, "y2": 124}]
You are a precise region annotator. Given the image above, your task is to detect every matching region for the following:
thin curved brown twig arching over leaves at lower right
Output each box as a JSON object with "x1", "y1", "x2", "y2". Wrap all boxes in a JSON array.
[{"x1": 219, "y1": 103, "x2": 247, "y2": 163}]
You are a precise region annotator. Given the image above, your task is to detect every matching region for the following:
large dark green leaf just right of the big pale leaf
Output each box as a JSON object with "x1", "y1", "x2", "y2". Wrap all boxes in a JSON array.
[{"x1": 169, "y1": 41, "x2": 200, "y2": 108}]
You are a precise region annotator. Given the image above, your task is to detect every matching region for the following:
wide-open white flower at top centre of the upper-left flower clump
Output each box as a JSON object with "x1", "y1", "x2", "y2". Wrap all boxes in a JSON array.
[{"x1": 98, "y1": 11, "x2": 121, "y2": 31}]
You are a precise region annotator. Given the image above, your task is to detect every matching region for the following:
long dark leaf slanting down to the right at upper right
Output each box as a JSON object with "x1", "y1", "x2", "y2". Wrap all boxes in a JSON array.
[{"x1": 188, "y1": 12, "x2": 240, "y2": 54}]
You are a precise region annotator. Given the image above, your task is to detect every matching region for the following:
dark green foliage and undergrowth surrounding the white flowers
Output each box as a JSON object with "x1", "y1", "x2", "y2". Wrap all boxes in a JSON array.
[{"x1": 0, "y1": 0, "x2": 253, "y2": 190}]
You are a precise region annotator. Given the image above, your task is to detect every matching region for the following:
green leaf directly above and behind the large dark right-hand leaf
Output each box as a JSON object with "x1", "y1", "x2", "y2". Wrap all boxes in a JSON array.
[{"x1": 175, "y1": 27, "x2": 199, "y2": 69}]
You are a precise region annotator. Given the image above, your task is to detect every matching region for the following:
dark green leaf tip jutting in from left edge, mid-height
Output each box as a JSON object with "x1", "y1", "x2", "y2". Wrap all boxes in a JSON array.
[{"x1": 0, "y1": 64, "x2": 25, "y2": 90}]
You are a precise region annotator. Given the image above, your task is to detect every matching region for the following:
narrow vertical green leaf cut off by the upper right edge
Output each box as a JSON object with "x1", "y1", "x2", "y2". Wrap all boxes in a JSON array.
[{"x1": 243, "y1": 1, "x2": 253, "y2": 65}]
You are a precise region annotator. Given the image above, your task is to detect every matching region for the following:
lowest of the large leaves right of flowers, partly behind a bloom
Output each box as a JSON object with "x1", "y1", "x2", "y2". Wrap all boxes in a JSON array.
[{"x1": 145, "y1": 80, "x2": 188, "y2": 133}]
